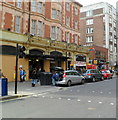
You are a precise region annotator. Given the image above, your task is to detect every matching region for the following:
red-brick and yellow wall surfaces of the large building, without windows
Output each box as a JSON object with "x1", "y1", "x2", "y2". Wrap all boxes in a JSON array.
[{"x1": 0, "y1": 0, "x2": 88, "y2": 81}]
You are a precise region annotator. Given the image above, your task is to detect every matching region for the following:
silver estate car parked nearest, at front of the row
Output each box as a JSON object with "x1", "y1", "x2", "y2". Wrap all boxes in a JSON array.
[{"x1": 56, "y1": 70, "x2": 85, "y2": 86}]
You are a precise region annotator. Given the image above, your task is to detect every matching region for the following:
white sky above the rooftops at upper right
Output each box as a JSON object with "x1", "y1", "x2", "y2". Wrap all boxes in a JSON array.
[{"x1": 76, "y1": 0, "x2": 118, "y2": 8}]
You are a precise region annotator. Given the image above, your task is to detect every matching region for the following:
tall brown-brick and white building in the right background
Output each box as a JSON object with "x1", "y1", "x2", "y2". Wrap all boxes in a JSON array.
[{"x1": 80, "y1": 2, "x2": 117, "y2": 67}]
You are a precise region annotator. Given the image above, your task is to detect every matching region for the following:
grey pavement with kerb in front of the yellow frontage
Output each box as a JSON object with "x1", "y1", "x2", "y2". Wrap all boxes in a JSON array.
[{"x1": 0, "y1": 80, "x2": 61, "y2": 101}]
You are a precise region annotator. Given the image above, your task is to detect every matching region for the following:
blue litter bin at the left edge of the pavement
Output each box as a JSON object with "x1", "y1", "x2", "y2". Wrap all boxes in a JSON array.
[{"x1": 0, "y1": 78, "x2": 8, "y2": 96}]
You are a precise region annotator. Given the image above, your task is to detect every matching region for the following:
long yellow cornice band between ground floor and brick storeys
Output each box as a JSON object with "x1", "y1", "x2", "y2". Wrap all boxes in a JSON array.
[{"x1": 0, "y1": 30, "x2": 89, "y2": 54}]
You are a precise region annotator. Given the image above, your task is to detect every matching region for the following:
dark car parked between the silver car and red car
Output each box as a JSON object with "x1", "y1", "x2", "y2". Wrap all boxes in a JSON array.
[{"x1": 83, "y1": 69, "x2": 104, "y2": 82}]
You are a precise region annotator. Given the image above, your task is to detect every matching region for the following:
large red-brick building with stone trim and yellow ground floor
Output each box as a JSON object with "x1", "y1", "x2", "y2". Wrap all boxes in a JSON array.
[{"x1": 0, "y1": 0, "x2": 88, "y2": 81}]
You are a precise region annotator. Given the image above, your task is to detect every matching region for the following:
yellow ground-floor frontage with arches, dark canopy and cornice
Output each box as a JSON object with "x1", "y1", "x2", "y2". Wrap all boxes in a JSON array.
[{"x1": 0, "y1": 31, "x2": 89, "y2": 81}]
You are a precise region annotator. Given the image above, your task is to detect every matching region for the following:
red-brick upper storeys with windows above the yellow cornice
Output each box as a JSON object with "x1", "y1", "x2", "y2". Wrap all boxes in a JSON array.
[{"x1": 0, "y1": 0, "x2": 81, "y2": 45}]
